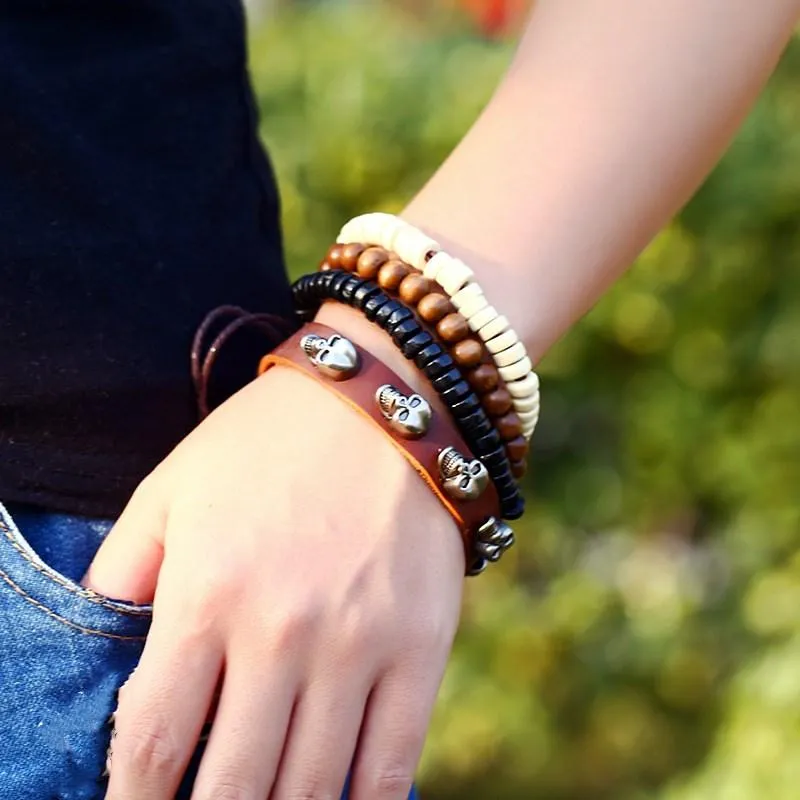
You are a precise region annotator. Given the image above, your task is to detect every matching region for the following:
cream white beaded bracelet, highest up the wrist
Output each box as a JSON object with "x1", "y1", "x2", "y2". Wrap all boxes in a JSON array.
[{"x1": 336, "y1": 213, "x2": 539, "y2": 439}]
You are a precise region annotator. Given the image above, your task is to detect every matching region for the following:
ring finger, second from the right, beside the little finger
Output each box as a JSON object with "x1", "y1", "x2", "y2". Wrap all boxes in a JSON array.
[{"x1": 269, "y1": 673, "x2": 369, "y2": 800}]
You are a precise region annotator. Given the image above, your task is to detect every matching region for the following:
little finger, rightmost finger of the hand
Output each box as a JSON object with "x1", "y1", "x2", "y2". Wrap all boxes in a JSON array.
[{"x1": 350, "y1": 665, "x2": 443, "y2": 800}]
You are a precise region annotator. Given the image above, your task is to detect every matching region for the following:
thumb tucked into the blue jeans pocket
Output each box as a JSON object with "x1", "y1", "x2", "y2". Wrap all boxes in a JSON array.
[{"x1": 82, "y1": 484, "x2": 167, "y2": 603}]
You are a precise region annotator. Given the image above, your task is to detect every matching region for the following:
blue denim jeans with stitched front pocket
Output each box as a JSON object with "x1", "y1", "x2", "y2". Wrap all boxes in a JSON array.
[{"x1": 0, "y1": 504, "x2": 416, "y2": 800}]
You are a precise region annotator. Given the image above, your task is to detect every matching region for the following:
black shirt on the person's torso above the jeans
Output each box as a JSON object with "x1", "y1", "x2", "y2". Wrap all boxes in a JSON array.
[{"x1": 0, "y1": 0, "x2": 290, "y2": 515}]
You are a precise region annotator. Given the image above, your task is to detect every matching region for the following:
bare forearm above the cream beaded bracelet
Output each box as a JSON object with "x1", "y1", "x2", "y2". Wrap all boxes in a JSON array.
[{"x1": 403, "y1": 0, "x2": 800, "y2": 360}]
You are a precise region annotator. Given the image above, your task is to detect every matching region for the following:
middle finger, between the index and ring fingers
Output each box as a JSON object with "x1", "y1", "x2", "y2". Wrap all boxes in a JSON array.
[{"x1": 192, "y1": 655, "x2": 298, "y2": 800}]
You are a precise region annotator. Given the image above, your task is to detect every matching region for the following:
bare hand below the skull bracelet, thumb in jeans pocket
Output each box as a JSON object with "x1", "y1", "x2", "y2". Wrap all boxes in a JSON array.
[{"x1": 86, "y1": 346, "x2": 464, "y2": 800}]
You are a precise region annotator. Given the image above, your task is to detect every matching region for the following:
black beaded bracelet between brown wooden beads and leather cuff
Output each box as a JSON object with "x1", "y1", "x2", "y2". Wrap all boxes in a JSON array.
[{"x1": 292, "y1": 270, "x2": 525, "y2": 520}]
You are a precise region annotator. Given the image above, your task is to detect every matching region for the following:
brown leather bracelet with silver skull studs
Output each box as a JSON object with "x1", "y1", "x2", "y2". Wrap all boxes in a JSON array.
[{"x1": 258, "y1": 323, "x2": 513, "y2": 574}]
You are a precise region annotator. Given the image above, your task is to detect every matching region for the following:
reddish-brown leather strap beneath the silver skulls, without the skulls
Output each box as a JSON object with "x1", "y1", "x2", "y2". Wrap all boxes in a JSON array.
[{"x1": 258, "y1": 322, "x2": 500, "y2": 569}]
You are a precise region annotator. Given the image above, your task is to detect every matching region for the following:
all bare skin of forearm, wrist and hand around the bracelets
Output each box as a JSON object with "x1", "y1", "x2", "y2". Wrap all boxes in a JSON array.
[{"x1": 86, "y1": 0, "x2": 800, "y2": 800}]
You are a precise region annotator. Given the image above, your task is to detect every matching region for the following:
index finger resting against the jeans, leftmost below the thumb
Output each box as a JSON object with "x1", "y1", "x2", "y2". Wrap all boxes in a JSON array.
[{"x1": 107, "y1": 587, "x2": 223, "y2": 800}]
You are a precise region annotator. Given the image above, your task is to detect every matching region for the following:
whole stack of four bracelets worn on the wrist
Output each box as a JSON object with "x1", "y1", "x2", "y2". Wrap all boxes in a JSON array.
[{"x1": 262, "y1": 214, "x2": 539, "y2": 575}]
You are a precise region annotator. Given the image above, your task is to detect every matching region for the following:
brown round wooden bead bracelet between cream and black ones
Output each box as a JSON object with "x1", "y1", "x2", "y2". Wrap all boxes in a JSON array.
[{"x1": 320, "y1": 243, "x2": 528, "y2": 478}]
